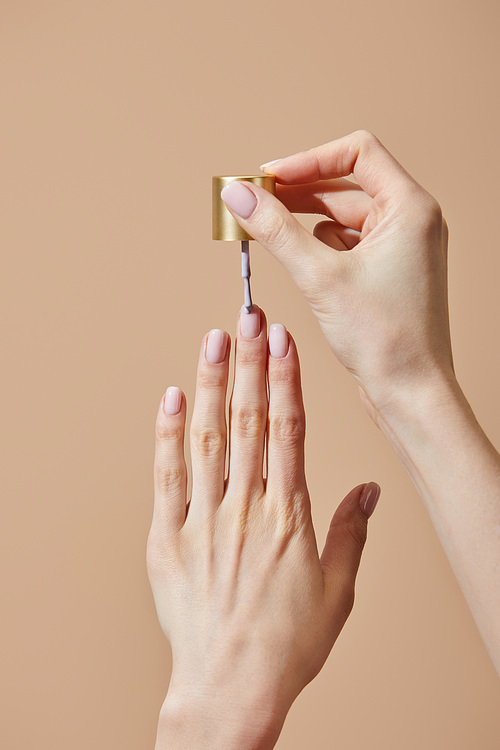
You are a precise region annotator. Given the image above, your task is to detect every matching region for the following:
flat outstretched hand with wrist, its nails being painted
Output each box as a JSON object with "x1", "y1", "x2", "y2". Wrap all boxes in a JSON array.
[{"x1": 148, "y1": 308, "x2": 380, "y2": 750}]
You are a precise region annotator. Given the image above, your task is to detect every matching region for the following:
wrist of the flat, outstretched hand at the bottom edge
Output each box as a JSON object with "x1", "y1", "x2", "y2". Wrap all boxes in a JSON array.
[{"x1": 155, "y1": 685, "x2": 288, "y2": 750}]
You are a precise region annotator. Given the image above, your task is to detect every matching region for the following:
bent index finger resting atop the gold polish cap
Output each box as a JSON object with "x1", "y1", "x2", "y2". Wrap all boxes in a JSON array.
[{"x1": 263, "y1": 130, "x2": 416, "y2": 198}]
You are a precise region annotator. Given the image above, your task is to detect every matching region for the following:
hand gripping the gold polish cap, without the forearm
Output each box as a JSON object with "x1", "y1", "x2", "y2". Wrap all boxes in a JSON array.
[{"x1": 223, "y1": 131, "x2": 454, "y2": 419}]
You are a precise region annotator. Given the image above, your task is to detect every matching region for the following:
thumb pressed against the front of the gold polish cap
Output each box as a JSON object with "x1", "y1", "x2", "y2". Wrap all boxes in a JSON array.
[{"x1": 221, "y1": 180, "x2": 326, "y2": 298}]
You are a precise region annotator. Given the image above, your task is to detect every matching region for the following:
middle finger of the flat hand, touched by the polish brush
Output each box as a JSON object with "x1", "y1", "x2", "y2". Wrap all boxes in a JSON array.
[{"x1": 228, "y1": 305, "x2": 267, "y2": 499}]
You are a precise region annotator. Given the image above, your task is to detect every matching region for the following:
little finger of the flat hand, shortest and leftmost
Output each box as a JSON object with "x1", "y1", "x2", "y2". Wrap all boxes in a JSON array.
[{"x1": 152, "y1": 387, "x2": 187, "y2": 536}]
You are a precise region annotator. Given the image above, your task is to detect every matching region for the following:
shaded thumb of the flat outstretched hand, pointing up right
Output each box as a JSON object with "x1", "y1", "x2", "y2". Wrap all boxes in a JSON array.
[{"x1": 321, "y1": 482, "x2": 380, "y2": 606}]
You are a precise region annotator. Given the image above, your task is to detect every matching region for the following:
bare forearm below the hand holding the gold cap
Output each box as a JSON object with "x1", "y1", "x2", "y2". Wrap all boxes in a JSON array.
[{"x1": 377, "y1": 376, "x2": 500, "y2": 674}]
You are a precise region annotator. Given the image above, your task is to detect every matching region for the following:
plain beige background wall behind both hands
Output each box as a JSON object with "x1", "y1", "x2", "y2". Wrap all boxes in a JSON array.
[{"x1": 0, "y1": 0, "x2": 500, "y2": 750}]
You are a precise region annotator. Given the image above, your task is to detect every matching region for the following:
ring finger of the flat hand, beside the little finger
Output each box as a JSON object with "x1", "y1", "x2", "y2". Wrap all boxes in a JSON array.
[{"x1": 189, "y1": 329, "x2": 230, "y2": 514}]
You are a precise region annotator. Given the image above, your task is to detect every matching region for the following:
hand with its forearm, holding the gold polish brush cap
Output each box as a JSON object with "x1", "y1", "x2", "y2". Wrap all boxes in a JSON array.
[{"x1": 222, "y1": 131, "x2": 500, "y2": 673}]
